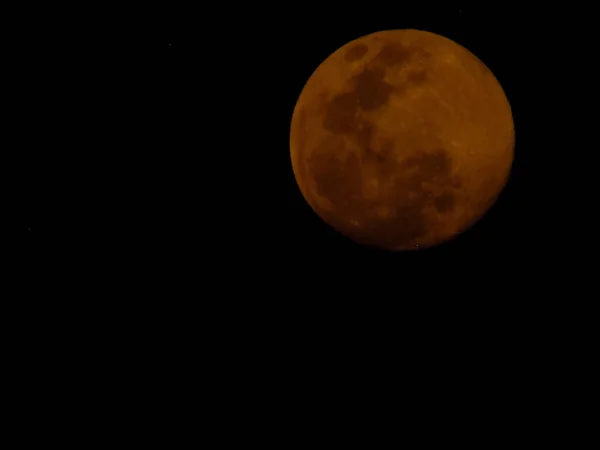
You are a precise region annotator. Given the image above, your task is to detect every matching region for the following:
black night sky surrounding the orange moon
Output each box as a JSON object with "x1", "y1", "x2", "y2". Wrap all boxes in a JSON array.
[{"x1": 11, "y1": 4, "x2": 597, "y2": 439}]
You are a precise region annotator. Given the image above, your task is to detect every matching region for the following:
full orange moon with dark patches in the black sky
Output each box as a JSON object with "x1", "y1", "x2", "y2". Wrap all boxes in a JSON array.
[{"x1": 290, "y1": 30, "x2": 515, "y2": 250}]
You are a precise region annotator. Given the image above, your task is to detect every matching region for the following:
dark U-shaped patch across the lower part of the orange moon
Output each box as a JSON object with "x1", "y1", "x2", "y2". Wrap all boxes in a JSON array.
[{"x1": 309, "y1": 141, "x2": 456, "y2": 247}]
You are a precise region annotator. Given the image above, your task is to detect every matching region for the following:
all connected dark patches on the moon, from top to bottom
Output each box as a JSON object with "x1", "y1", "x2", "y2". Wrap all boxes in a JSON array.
[{"x1": 307, "y1": 38, "x2": 460, "y2": 248}]
